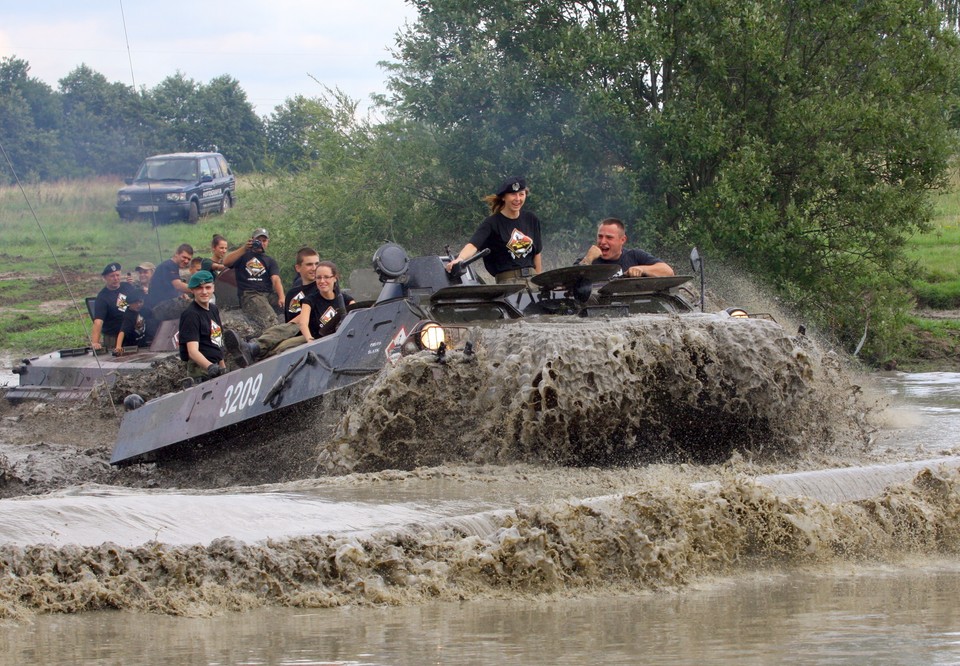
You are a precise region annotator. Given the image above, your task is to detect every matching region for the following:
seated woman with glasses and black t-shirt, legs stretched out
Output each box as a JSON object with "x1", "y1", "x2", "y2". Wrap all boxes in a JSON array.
[{"x1": 224, "y1": 261, "x2": 354, "y2": 368}]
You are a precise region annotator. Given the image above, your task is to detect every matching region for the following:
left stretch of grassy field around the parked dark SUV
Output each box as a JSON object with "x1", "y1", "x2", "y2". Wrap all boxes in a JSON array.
[{"x1": 0, "y1": 178, "x2": 260, "y2": 354}]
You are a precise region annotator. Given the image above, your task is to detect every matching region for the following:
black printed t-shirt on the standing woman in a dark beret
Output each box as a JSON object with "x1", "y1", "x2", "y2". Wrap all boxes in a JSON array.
[{"x1": 470, "y1": 210, "x2": 543, "y2": 276}]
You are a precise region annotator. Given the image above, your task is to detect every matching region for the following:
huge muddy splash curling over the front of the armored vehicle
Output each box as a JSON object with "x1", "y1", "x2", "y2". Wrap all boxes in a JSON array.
[{"x1": 320, "y1": 315, "x2": 867, "y2": 473}]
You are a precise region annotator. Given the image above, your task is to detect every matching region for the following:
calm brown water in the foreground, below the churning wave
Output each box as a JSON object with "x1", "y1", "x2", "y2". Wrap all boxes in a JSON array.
[{"x1": 0, "y1": 558, "x2": 960, "y2": 665}]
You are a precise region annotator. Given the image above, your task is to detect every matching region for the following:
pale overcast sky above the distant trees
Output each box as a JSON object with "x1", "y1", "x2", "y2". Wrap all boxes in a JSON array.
[{"x1": 0, "y1": 0, "x2": 416, "y2": 115}]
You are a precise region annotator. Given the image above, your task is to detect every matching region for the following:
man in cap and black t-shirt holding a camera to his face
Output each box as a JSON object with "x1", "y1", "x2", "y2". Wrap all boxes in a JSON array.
[{"x1": 223, "y1": 229, "x2": 286, "y2": 331}]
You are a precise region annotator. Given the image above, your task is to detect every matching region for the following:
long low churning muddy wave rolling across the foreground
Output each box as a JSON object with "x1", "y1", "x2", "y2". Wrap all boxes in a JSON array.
[{"x1": 0, "y1": 462, "x2": 960, "y2": 618}]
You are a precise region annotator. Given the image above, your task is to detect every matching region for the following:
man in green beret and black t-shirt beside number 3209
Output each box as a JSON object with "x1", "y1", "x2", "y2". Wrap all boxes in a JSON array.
[{"x1": 179, "y1": 271, "x2": 226, "y2": 381}]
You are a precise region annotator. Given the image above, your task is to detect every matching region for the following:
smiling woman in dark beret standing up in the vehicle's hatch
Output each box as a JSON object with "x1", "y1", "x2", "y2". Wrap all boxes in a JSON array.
[{"x1": 446, "y1": 176, "x2": 543, "y2": 284}]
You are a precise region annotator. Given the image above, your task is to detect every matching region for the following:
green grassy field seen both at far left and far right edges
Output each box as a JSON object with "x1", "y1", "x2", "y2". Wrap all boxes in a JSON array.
[{"x1": 0, "y1": 174, "x2": 960, "y2": 369}]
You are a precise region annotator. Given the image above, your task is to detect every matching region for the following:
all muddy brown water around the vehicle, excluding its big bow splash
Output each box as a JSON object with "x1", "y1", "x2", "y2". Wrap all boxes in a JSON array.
[{"x1": 0, "y1": 366, "x2": 960, "y2": 664}]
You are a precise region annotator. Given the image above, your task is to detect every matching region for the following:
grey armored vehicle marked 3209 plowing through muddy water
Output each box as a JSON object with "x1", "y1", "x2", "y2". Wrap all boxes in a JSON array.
[{"x1": 111, "y1": 244, "x2": 744, "y2": 464}]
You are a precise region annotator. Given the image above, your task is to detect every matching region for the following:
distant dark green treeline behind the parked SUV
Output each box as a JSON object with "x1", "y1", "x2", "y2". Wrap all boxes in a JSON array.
[{"x1": 0, "y1": 57, "x2": 314, "y2": 183}]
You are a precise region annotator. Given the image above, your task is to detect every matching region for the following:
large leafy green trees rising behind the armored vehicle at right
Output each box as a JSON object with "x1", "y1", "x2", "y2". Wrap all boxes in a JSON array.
[{"x1": 389, "y1": 0, "x2": 960, "y2": 356}]
